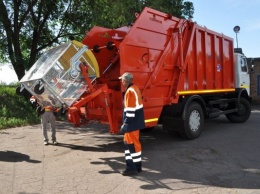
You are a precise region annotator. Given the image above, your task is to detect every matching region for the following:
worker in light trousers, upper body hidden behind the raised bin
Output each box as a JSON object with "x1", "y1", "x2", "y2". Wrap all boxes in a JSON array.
[{"x1": 30, "y1": 96, "x2": 58, "y2": 145}]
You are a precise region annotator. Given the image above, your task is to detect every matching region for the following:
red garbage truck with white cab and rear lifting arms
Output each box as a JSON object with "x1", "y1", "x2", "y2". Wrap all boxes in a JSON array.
[{"x1": 18, "y1": 8, "x2": 251, "y2": 139}]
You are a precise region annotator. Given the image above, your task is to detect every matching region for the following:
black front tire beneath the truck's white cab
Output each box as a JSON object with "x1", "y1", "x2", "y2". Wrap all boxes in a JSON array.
[{"x1": 226, "y1": 97, "x2": 251, "y2": 123}]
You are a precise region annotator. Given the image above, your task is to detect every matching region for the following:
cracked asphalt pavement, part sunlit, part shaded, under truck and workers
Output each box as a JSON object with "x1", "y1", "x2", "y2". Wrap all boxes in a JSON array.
[{"x1": 0, "y1": 108, "x2": 260, "y2": 194}]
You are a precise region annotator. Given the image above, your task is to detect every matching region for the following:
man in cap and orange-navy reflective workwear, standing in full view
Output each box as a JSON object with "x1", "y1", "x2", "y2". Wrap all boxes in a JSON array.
[{"x1": 119, "y1": 72, "x2": 145, "y2": 176}]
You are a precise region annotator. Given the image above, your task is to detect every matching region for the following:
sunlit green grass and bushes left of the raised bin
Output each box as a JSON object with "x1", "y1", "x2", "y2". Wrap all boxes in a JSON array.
[{"x1": 0, "y1": 85, "x2": 40, "y2": 129}]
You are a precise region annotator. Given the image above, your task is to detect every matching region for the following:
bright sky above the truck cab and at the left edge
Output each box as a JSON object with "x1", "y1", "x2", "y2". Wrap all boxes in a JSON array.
[{"x1": 0, "y1": 0, "x2": 260, "y2": 84}]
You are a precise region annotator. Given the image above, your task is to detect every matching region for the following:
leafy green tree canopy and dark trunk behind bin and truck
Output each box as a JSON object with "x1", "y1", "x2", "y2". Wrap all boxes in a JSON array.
[{"x1": 0, "y1": 0, "x2": 194, "y2": 80}]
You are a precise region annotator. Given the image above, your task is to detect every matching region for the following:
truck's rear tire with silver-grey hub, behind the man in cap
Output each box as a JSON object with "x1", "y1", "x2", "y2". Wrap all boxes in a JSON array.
[{"x1": 183, "y1": 102, "x2": 204, "y2": 140}]
